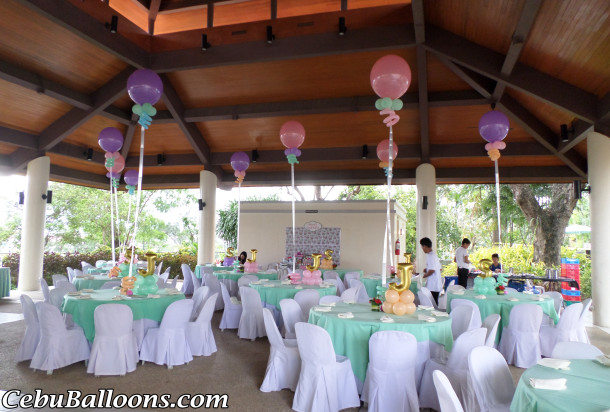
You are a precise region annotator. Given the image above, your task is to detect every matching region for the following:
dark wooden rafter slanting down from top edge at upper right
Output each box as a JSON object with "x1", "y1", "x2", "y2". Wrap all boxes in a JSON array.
[{"x1": 492, "y1": 0, "x2": 542, "y2": 102}]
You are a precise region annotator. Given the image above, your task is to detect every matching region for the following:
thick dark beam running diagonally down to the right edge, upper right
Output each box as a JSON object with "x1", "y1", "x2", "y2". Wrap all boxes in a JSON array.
[{"x1": 425, "y1": 26, "x2": 597, "y2": 123}]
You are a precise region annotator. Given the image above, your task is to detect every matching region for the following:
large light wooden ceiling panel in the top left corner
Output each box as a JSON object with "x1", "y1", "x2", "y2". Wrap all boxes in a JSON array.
[{"x1": 0, "y1": 0, "x2": 127, "y2": 94}]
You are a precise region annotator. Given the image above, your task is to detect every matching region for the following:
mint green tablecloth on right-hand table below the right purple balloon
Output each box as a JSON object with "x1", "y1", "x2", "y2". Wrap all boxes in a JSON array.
[{"x1": 447, "y1": 290, "x2": 559, "y2": 342}]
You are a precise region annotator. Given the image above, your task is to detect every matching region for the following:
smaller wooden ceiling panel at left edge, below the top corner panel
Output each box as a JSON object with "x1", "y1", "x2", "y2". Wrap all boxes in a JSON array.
[{"x1": 0, "y1": 80, "x2": 71, "y2": 134}]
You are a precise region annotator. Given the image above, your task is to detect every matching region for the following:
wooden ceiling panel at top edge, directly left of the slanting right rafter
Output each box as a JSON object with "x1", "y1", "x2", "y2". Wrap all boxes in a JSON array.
[{"x1": 424, "y1": 0, "x2": 525, "y2": 54}]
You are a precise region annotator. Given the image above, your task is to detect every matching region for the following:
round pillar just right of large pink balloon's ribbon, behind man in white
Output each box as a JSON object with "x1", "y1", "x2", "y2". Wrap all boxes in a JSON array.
[{"x1": 415, "y1": 163, "x2": 436, "y2": 272}]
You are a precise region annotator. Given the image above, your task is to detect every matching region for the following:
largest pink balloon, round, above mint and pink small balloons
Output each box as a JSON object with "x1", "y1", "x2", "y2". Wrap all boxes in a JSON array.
[{"x1": 371, "y1": 54, "x2": 411, "y2": 99}]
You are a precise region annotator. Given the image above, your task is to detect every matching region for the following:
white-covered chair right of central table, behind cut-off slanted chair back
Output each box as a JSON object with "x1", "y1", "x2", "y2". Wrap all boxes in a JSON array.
[{"x1": 419, "y1": 328, "x2": 487, "y2": 411}]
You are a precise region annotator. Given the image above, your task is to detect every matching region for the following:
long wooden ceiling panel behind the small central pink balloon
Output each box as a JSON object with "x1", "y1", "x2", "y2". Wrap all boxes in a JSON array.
[{"x1": 197, "y1": 110, "x2": 419, "y2": 152}]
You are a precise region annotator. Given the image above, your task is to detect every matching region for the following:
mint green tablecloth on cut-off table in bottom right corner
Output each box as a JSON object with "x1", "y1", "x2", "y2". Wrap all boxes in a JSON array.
[{"x1": 510, "y1": 360, "x2": 610, "y2": 412}]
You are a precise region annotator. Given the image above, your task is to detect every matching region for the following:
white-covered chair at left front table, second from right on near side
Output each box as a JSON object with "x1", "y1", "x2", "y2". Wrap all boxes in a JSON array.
[{"x1": 140, "y1": 299, "x2": 193, "y2": 369}]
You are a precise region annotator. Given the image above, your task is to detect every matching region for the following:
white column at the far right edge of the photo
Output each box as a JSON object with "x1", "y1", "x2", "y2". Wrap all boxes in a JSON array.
[{"x1": 587, "y1": 132, "x2": 610, "y2": 328}]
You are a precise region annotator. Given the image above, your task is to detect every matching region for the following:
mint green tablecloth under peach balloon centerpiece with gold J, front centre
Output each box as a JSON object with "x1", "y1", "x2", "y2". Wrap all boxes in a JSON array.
[{"x1": 309, "y1": 303, "x2": 453, "y2": 382}]
